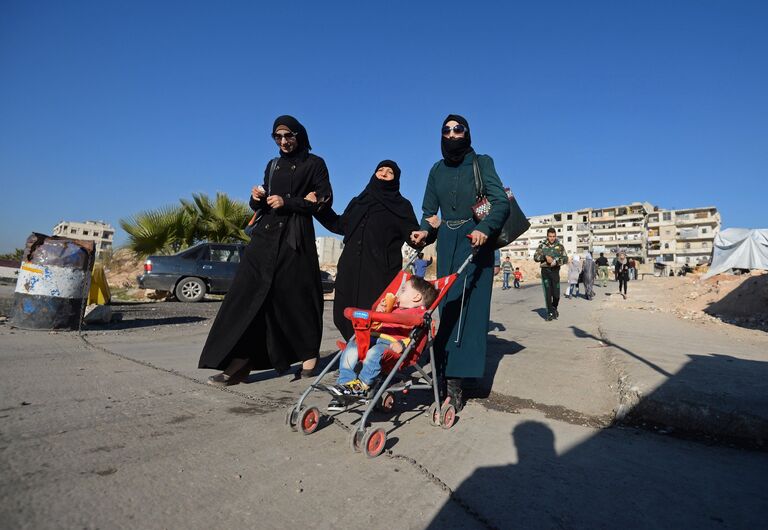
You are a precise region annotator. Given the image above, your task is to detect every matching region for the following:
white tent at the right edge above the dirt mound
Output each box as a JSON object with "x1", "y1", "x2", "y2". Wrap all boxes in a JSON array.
[{"x1": 704, "y1": 228, "x2": 768, "y2": 278}]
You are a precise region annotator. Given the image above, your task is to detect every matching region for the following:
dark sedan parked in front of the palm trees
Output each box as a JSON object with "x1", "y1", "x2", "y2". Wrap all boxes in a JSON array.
[{"x1": 137, "y1": 243, "x2": 335, "y2": 302}]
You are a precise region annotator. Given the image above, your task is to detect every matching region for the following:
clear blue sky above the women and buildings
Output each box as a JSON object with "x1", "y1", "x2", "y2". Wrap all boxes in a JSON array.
[{"x1": 0, "y1": 0, "x2": 768, "y2": 252}]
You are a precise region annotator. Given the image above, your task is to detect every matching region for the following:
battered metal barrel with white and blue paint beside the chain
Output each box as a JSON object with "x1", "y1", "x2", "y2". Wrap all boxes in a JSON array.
[{"x1": 10, "y1": 233, "x2": 94, "y2": 330}]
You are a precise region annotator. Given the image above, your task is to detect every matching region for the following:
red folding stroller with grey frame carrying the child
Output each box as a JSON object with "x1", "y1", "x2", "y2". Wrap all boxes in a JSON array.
[{"x1": 286, "y1": 255, "x2": 472, "y2": 458}]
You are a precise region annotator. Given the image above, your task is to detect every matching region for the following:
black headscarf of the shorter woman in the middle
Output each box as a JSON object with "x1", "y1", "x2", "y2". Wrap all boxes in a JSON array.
[{"x1": 344, "y1": 160, "x2": 413, "y2": 242}]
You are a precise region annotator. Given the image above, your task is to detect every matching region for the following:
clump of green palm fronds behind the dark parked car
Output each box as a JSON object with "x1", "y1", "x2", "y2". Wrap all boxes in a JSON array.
[{"x1": 120, "y1": 193, "x2": 251, "y2": 257}]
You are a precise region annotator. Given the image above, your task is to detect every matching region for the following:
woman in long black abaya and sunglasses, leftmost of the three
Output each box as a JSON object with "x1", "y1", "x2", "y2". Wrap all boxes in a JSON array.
[{"x1": 198, "y1": 116, "x2": 332, "y2": 385}]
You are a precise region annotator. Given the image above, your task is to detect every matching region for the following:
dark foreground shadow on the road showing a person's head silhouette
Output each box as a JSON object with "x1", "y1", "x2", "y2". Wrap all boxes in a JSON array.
[{"x1": 428, "y1": 421, "x2": 768, "y2": 530}]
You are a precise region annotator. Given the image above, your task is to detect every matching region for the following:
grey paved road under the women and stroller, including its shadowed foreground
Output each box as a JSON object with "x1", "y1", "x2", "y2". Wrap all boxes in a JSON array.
[{"x1": 0, "y1": 282, "x2": 768, "y2": 529}]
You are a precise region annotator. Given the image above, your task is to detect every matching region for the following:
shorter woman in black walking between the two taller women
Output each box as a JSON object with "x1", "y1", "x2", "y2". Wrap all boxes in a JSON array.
[{"x1": 310, "y1": 160, "x2": 419, "y2": 340}]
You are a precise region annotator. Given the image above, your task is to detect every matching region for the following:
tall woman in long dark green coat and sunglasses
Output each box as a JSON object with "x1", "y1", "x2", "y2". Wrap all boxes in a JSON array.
[{"x1": 411, "y1": 114, "x2": 509, "y2": 410}]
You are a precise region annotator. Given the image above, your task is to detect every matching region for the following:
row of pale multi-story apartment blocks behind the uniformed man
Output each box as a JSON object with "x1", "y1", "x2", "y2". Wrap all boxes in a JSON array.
[{"x1": 502, "y1": 202, "x2": 720, "y2": 266}]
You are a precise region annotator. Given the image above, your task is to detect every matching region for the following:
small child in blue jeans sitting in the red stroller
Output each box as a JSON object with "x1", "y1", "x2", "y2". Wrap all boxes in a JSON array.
[{"x1": 327, "y1": 276, "x2": 438, "y2": 411}]
